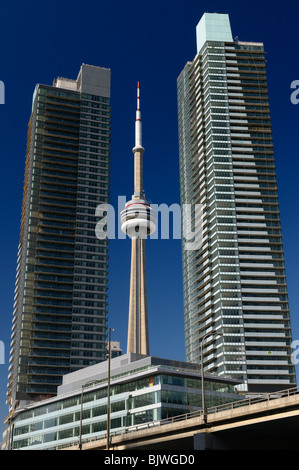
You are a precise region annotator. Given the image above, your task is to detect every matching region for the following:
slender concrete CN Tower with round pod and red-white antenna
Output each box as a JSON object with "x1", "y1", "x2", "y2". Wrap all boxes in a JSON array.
[{"x1": 121, "y1": 82, "x2": 156, "y2": 355}]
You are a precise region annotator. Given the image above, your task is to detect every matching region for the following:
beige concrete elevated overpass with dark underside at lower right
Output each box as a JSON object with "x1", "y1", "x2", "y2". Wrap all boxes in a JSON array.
[{"x1": 64, "y1": 388, "x2": 299, "y2": 451}]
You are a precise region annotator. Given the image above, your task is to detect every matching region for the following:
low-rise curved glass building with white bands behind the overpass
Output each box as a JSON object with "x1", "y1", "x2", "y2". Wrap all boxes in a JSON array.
[{"x1": 6, "y1": 354, "x2": 244, "y2": 450}]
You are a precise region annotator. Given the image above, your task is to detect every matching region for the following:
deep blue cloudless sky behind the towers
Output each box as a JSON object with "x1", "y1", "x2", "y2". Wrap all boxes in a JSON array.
[{"x1": 0, "y1": 0, "x2": 299, "y2": 436}]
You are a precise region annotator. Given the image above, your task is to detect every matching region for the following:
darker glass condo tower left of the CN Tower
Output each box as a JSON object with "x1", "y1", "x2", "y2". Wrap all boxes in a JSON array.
[{"x1": 8, "y1": 64, "x2": 110, "y2": 407}]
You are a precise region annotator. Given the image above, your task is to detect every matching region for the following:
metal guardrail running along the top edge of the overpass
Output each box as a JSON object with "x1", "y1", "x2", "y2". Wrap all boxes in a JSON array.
[{"x1": 55, "y1": 387, "x2": 299, "y2": 450}]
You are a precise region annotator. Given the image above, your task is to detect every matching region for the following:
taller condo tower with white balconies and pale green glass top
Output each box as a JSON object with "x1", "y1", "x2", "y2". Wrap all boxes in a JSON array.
[{"x1": 177, "y1": 13, "x2": 296, "y2": 392}]
